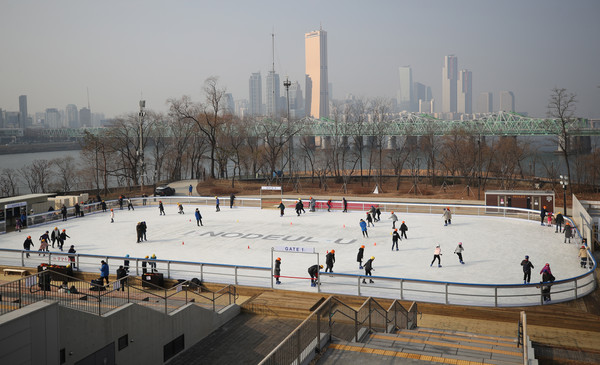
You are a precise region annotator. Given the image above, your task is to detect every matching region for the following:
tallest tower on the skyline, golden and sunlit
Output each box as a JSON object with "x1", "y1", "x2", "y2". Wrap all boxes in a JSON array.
[{"x1": 304, "y1": 29, "x2": 329, "y2": 118}]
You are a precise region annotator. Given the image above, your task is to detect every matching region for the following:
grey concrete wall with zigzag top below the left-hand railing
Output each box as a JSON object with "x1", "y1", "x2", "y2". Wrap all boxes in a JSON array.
[{"x1": 0, "y1": 301, "x2": 240, "y2": 365}]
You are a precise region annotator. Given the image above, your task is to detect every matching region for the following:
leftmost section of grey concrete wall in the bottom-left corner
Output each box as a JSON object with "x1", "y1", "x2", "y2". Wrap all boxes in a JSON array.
[{"x1": 0, "y1": 301, "x2": 60, "y2": 365}]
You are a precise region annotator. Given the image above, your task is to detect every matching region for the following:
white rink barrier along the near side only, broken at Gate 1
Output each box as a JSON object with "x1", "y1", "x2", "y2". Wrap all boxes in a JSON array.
[{"x1": 0, "y1": 245, "x2": 597, "y2": 307}]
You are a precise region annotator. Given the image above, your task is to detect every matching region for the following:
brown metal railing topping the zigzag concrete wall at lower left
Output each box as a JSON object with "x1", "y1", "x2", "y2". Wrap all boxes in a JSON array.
[{"x1": 0, "y1": 270, "x2": 237, "y2": 315}]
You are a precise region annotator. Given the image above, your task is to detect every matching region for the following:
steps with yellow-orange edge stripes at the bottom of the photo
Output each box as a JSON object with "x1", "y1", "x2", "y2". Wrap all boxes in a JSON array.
[{"x1": 318, "y1": 328, "x2": 523, "y2": 365}]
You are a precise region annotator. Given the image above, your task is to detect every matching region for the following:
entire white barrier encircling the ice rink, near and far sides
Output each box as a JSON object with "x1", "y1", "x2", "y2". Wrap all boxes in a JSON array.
[{"x1": 0, "y1": 196, "x2": 597, "y2": 307}]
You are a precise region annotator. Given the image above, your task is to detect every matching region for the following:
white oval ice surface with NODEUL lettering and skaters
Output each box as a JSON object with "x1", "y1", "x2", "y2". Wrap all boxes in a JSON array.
[{"x1": 0, "y1": 201, "x2": 586, "y2": 286}]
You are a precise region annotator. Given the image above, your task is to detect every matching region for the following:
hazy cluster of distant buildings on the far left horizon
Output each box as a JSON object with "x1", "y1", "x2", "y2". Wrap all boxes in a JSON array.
[{"x1": 0, "y1": 95, "x2": 106, "y2": 129}]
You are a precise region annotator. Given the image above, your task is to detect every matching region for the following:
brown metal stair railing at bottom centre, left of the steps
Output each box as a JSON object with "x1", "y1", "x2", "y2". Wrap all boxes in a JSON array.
[{"x1": 259, "y1": 297, "x2": 417, "y2": 365}]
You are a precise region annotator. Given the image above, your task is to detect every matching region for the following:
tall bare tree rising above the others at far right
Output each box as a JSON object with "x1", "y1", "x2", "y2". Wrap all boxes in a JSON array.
[{"x1": 548, "y1": 87, "x2": 577, "y2": 194}]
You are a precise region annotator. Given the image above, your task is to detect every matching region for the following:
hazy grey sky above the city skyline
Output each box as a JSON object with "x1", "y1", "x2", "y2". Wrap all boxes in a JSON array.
[{"x1": 0, "y1": 0, "x2": 600, "y2": 118}]
